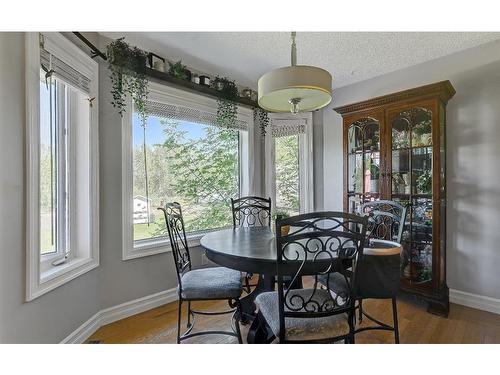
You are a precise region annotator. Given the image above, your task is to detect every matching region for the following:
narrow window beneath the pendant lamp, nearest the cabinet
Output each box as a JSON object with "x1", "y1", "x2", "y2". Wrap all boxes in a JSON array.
[{"x1": 265, "y1": 114, "x2": 313, "y2": 215}]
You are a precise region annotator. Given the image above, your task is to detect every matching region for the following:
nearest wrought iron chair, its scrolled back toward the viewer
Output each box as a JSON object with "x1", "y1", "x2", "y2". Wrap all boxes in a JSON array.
[{"x1": 255, "y1": 212, "x2": 367, "y2": 343}]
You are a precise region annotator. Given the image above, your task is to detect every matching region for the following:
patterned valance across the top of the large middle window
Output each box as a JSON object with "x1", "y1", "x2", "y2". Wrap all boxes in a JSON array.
[{"x1": 146, "y1": 100, "x2": 248, "y2": 130}]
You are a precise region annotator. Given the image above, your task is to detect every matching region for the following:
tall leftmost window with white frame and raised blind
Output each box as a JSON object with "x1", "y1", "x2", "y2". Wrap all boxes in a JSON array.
[{"x1": 26, "y1": 33, "x2": 99, "y2": 300}]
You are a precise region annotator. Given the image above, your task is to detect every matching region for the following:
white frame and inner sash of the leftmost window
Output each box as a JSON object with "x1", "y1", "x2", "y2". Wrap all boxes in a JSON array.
[{"x1": 25, "y1": 32, "x2": 99, "y2": 301}]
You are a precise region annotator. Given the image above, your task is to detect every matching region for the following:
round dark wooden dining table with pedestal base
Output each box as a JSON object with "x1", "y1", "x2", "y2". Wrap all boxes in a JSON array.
[{"x1": 200, "y1": 226, "x2": 401, "y2": 343}]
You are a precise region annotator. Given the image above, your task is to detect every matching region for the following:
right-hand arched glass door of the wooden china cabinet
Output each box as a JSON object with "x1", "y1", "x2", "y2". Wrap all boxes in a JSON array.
[{"x1": 389, "y1": 107, "x2": 433, "y2": 284}]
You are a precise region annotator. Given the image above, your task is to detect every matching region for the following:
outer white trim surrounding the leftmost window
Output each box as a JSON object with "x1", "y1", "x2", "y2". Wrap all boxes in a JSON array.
[{"x1": 25, "y1": 33, "x2": 99, "y2": 301}]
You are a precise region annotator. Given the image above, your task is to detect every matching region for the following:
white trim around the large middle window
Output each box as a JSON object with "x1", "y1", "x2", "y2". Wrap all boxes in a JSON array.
[{"x1": 122, "y1": 82, "x2": 254, "y2": 260}]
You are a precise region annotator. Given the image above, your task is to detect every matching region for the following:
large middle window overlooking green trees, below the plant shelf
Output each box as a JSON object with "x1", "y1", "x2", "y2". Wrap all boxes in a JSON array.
[{"x1": 123, "y1": 83, "x2": 253, "y2": 259}]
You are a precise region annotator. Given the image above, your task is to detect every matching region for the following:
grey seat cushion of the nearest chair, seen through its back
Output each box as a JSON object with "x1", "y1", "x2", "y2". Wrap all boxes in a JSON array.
[{"x1": 255, "y1": 289, "x2": 349, "y2": 341}]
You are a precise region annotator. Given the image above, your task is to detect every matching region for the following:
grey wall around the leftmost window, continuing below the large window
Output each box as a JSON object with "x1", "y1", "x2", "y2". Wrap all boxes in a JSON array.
[{"x1": 0, "y1": 33, "x2": 201, "y2": 343}]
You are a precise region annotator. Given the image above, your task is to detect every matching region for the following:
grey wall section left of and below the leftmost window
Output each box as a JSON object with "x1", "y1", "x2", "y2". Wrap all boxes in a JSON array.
[{"x1": 0, "y1": 33, "x2": 101, "y2": 343}]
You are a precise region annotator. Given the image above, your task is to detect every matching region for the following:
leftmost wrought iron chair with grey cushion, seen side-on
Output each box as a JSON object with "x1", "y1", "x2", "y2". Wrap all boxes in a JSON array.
[{"x1": 159, "y1": 202, "x2": 242, "y2": 344}]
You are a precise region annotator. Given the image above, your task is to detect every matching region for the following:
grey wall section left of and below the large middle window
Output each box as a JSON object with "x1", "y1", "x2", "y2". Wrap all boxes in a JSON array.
[{"x1": 99, "y1": 37, "x2": 201, "y2": 308}]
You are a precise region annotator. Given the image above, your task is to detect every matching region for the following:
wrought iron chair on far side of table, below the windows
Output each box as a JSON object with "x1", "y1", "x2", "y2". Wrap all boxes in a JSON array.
[{"x1": 231, "y1": 196, "x2": 271, "y2": 293}]
